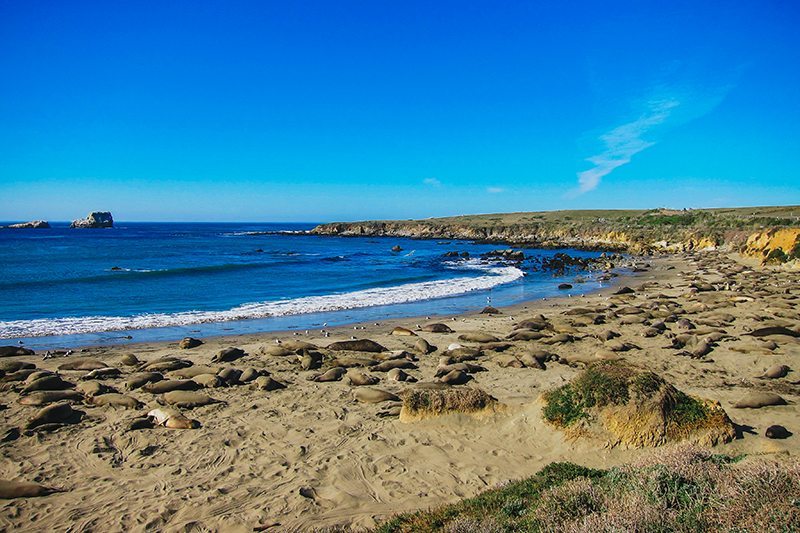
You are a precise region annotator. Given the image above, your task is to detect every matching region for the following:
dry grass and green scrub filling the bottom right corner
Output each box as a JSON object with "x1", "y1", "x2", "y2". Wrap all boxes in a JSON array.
[{"x1": 378, "y1": 445, "x2": 800, "y2": 533}]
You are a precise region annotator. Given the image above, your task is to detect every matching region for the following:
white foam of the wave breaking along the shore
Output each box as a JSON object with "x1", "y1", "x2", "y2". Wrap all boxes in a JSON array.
[{"x1": 0, "y1": 262, "x2": 524, "y2": 339}]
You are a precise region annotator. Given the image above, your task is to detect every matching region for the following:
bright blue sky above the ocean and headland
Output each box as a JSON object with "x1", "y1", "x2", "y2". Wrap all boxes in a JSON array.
[{"x1": 0, "y1": 0, "x2": 800, "y2": 221}]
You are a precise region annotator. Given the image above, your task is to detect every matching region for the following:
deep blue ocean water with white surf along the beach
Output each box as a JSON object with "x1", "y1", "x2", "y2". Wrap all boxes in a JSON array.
[{"x1": 0, "y1": 223, "x2": 612, "y2": 348}]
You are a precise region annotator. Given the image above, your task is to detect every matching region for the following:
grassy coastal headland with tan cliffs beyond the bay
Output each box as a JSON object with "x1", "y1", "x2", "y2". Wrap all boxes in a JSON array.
[{"x1": 311, "y1": 206, "x2": 800, "y2": 259}]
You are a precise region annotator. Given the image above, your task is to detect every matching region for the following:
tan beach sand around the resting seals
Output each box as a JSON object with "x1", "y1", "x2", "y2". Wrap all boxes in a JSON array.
[{"x1": 0, "y1": 253, "x2": 800, "y2": 531}]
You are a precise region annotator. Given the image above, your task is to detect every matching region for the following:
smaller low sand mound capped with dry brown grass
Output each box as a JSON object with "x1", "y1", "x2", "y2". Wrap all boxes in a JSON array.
[{"x1": 400, "y1": 387, "x2": 501, "y2": 422}]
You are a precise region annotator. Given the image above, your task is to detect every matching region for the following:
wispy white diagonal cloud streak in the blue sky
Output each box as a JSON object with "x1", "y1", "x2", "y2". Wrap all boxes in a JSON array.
[{"x1": 576, "y1": 98, "x2": 681, "y2": 194}]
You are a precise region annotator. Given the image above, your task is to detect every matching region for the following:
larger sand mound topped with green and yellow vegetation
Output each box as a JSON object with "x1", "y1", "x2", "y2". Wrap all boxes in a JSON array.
[{"x1": 542, "y1": 361, "x2": 736, "y2": 447}]
